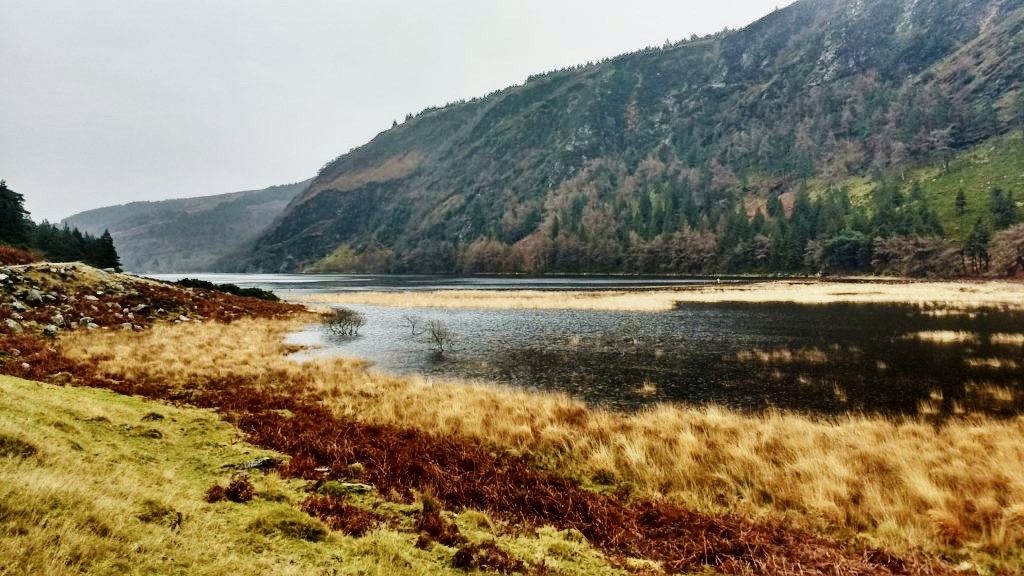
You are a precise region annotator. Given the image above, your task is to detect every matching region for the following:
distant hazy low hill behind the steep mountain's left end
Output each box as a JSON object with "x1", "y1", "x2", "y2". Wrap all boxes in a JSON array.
[{"x1": 63, "y1": 180, "x2": 309, "y2": 273}]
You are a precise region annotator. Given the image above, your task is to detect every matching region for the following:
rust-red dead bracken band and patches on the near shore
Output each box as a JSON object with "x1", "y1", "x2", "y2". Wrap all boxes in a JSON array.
[{"x1": 0, "y1": 262, "x2": 983, "y2": 575}]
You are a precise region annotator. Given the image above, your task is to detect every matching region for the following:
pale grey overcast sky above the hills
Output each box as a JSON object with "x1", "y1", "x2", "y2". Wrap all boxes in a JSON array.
[{"x1": 0, "y1": 0, "x2": 788, "y2": 221}]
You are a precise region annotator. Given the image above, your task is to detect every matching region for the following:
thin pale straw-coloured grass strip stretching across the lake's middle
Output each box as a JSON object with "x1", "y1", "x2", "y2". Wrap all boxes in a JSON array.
[{"x1": 300, "y1": 281, "x2": 1024, "y2": 314}]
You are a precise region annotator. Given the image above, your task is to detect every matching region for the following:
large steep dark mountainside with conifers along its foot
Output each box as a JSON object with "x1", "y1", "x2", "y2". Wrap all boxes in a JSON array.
[{"x1": 235, "y1": 0, "x2": 1024, "y2": 273}]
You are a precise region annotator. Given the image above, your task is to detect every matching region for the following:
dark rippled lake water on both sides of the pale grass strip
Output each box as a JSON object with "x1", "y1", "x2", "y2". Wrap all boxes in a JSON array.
[{"x1": 149, "y1": 275, "x2": 1024, "y2": 418}]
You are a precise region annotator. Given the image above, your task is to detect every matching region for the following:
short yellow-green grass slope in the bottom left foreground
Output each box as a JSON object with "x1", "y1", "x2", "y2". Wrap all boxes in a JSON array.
[{"x1": 0, "y1": 376, "x2": 622, "y2": 576}]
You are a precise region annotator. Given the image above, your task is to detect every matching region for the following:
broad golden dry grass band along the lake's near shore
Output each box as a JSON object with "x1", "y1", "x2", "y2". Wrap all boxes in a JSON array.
[{"x1": 62, "y1": 317, "x2": 1024, "y2": 568}]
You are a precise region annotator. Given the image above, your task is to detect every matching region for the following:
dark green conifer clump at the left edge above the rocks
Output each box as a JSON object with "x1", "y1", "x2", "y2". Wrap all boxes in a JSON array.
[{"x1": 0, "y1": 180, "x2": 121, "y2": 272}]
